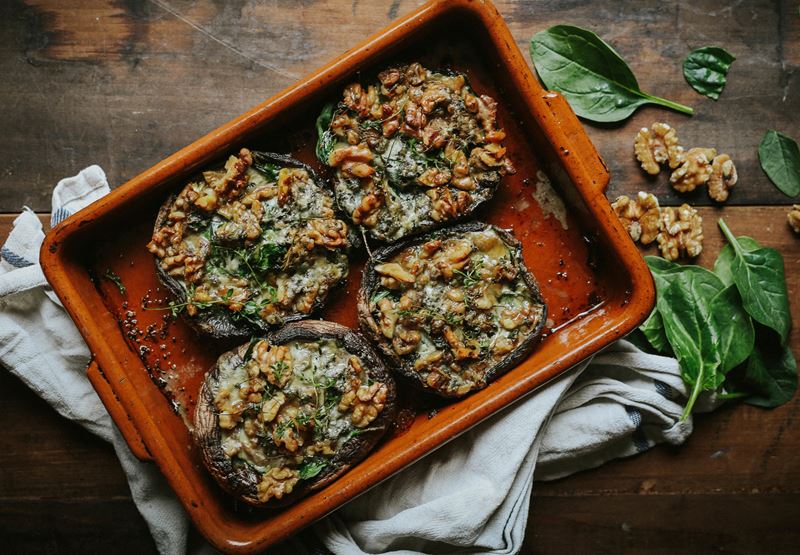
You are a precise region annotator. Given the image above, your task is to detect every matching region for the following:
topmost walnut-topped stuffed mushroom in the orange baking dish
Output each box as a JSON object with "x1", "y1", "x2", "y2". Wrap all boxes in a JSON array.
[{"x1": 317, "y1": 63, "x2": 514, "y2": 242}]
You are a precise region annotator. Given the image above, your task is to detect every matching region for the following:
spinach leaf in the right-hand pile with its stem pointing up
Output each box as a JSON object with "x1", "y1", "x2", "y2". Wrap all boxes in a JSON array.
[{"x1": 719, "y1": 218, "x2": 792, "y2": 344}]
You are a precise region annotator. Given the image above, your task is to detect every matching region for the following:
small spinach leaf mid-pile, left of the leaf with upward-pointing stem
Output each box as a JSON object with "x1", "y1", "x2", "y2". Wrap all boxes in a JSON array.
[{"x1": 709, "y1": 285, "x2": 756, "y2": 374}]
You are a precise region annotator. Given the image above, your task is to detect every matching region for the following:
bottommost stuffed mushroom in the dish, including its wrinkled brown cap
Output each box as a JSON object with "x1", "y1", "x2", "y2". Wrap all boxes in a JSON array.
[{"x1": 194, "y1": 321, "x2": 395, "y2": 507}]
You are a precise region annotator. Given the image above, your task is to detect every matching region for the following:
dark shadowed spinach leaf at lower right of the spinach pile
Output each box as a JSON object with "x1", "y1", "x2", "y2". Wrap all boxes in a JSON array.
[{"x1": 744, "y1": 338, "x2": 797, "y2": 408}]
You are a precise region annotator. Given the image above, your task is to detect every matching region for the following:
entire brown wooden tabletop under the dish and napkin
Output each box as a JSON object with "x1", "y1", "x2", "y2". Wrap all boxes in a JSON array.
[{"x1": 0, "y1": 0, "x2": 800, "y2": 553}]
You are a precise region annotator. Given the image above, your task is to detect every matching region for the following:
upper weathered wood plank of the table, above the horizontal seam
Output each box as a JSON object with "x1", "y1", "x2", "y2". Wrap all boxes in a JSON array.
[{"x1": 0, "y1": 0, "x2": 800, "y2": 212}]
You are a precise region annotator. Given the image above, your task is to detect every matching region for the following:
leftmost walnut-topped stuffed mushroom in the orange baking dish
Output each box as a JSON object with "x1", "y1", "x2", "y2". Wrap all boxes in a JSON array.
[{"x1": 148, "y1": 149, "x2": 356, "y2": 337}]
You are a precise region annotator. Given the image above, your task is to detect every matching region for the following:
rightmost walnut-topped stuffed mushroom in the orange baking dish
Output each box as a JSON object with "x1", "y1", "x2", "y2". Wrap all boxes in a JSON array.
[{"x1": 358, "y1": 222, "x2": 547, "y2": 397}]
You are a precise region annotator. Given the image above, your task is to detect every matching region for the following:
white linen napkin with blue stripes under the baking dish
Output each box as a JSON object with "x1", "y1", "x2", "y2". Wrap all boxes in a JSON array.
[{"x1": 0, "y1": 166, "x2": 700, "y2": 554}]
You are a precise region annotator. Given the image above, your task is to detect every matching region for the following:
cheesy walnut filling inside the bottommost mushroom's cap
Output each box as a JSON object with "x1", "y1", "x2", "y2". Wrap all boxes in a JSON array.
[{"x1": 214, "y1": 338, "x2": 388, "y2": 502}]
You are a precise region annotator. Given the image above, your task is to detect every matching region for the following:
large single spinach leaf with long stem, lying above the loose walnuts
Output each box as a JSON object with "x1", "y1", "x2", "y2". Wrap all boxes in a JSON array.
[{"x1": 530, "y1": 25, "x2": 693, "y2": 122}]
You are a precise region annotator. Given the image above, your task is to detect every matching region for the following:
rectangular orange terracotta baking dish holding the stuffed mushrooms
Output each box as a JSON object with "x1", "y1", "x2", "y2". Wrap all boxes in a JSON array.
[{"x1": 41, "y1": 0, "x2": 654, "y2": 553}]
